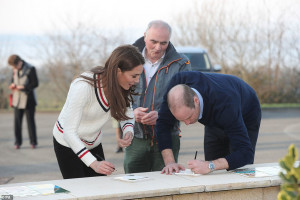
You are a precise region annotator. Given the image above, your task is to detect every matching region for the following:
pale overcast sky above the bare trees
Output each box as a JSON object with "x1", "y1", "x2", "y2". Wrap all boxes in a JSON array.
[{"x1": 0, "y1": 0, "x2": 300, "y2": 63}]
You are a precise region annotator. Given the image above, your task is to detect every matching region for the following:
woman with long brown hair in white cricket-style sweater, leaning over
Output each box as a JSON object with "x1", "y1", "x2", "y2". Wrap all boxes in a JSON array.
[{"x1": 53, "y1": 45, "x2": 145, "y2": 179}]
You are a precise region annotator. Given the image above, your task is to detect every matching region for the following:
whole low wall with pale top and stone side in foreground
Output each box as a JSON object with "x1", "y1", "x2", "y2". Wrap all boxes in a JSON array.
[{"x1": 0, "y1": 163, "x2": 281, "y2": 200}]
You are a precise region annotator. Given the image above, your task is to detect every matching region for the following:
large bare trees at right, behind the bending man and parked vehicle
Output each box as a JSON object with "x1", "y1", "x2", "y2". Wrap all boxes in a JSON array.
[{"x1": 174, "y1": 0, "x2": 300, "y2": 103}]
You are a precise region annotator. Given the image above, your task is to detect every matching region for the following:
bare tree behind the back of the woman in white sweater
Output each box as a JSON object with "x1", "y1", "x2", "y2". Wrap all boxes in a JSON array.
[{"x1": 38, "y1": 20, "x2": 125, "y2": 106}]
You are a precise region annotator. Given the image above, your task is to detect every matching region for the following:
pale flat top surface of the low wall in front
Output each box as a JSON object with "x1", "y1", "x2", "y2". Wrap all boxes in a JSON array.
[{"x1": 0, "y1": 163, "x2": 281, "y2": 200}]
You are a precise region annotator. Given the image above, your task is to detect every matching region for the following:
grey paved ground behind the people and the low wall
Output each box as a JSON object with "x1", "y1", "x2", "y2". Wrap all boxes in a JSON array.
[{"x1": 0, "y1": 109, "x2": 300, "y2": 184}]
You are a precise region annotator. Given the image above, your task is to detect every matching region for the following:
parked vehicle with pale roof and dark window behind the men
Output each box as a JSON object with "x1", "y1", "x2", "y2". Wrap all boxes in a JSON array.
[{"x1": 175, "y1": 46, "x2": 221, "y2": 72}]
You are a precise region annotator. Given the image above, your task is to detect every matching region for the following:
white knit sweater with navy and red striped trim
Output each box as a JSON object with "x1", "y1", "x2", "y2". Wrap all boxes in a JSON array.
[{"x1": 53, "y1": 73, "x2": 134, "y2": 166}]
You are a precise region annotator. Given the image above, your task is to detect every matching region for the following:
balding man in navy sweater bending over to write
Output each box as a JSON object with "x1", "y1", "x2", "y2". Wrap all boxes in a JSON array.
[{"x1": 156, "y1": 72, "x2": 261, "y2": 174}]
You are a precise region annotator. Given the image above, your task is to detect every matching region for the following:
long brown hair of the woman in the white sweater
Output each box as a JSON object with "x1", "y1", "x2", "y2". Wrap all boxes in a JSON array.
[{"x1": 80, "y1": 45, "x2": 145, "y2": 121}]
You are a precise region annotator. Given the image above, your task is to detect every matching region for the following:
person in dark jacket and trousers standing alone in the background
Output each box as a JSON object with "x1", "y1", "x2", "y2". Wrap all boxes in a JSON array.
[{"x1": 8, "y1": 55, "x2": 38, "y2": 149}]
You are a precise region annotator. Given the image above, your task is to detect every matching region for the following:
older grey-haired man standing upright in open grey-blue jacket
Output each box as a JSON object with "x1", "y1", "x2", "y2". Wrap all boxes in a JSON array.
[{"x1": 124, "y1": 20, "x2": 191, "y2": 173}]
